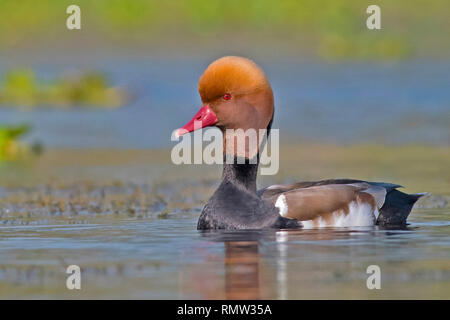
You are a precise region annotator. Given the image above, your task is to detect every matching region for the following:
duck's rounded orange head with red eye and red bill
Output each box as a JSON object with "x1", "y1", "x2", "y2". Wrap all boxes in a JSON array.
[{"x1": 176, "y1": 56, "x2": 273, "y2": 136}]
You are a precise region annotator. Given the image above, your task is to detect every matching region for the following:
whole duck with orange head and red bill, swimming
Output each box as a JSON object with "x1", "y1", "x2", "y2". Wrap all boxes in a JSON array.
[{"x1": 175, "y1": 56, "x2": 425, "y2": 230}]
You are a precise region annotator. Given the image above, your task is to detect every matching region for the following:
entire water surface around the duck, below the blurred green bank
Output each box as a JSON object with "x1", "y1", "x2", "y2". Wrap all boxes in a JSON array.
[{"x1": 0, "y1": 55, "x2": 450, "y2": 299}]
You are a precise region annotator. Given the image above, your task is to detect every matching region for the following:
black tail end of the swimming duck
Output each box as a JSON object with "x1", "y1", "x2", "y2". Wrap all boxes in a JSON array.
[{"x1": 377, "y1": 189, "x2": 426, "y2": 226}]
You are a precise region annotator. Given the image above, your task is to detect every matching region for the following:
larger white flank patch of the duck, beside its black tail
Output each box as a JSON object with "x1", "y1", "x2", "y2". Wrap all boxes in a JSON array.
[{"x1": 302, "y1": 200, "x2": 379, "y2": 229}]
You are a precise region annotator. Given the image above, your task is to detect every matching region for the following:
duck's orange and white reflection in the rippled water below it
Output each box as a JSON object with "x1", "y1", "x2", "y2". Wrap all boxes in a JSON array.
[{"x1": 190, "y1": 227, "x2": 409, "y2": 300}]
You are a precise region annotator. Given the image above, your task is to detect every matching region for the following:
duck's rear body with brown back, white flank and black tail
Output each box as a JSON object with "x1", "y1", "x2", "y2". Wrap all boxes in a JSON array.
[{"x1": 258, "y1": 179, "x2": 424, "y2": 228}]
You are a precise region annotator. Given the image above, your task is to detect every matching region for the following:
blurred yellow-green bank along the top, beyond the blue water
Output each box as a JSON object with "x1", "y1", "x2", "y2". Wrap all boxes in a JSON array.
[{"x1": 0, "y1": 0, "x2": 450, "y2": 60}]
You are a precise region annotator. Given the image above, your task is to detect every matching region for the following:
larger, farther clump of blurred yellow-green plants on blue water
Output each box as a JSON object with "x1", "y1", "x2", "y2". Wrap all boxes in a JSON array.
[{"x1": 0, "y1": 70, "x2": 127, "y2": 108}]
